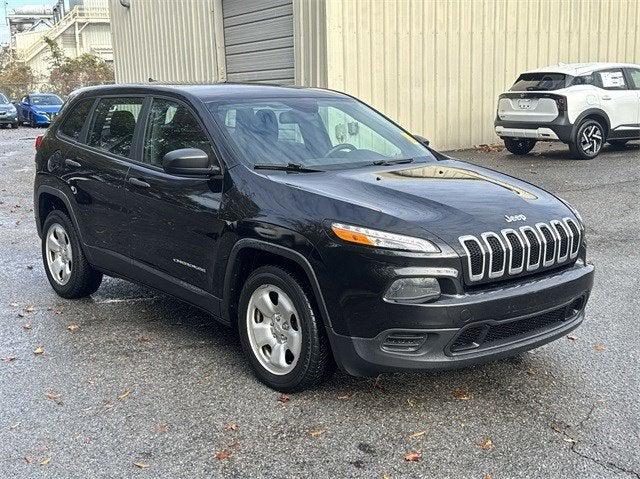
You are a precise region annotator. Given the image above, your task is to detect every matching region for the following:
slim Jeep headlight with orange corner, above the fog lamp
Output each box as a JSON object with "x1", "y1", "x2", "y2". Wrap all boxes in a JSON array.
[{"x1": 331, "y1": 223, "x2": 440, "y2": 253}]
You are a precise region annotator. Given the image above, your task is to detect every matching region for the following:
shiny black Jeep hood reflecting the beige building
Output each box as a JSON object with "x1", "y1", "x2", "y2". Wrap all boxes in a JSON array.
[{"x1": 264, "y1": 160, "x2": 574, "y2": 246}]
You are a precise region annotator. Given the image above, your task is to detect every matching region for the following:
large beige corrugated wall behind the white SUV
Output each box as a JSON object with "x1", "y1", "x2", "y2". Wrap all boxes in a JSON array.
[{"x1": 319, "y1": 0, "x2": 640, "y2": 149}]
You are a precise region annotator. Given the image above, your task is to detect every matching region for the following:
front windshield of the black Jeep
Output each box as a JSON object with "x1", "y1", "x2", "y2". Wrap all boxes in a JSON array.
[{"x1": 208, "y1": 97, "x2": 434, "y2": 169}]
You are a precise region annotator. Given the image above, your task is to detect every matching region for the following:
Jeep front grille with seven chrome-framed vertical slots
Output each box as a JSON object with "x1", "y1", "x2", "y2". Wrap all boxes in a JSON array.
[{"x1": 459, "y1": 218, "x2": 581, "y2": 283}]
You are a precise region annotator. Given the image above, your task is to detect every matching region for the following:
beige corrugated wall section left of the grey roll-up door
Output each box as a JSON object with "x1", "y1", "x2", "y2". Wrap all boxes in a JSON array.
[{"x1": 109, "y1": 0, "x2": 219, "y2": 83}]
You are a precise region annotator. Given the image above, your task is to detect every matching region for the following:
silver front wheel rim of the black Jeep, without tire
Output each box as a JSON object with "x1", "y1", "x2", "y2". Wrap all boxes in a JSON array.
[{"x1": 246, "y1": 284, "x2": 302, "y2": 376}]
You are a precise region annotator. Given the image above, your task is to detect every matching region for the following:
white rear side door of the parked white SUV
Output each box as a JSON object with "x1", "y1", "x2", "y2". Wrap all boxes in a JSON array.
[{"x1": 595, "y1": 68, "x2": 638, "y2": 132}]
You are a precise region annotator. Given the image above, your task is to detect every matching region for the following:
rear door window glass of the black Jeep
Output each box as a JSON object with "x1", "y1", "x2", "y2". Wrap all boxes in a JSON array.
[{"x1": 87, "y1": 98, "x2": 144, "y2": 156}]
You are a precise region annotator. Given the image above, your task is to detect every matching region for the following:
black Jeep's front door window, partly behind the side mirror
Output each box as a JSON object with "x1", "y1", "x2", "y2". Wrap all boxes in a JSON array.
[{"x1": 143, "y1": 99, "x2": 213, "y2": 166}]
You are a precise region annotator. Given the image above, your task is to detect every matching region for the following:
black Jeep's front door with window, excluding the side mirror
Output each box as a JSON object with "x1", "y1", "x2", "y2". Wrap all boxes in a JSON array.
[{"x1": 126, "y1": 98, "x2": 222, "y2": 290}]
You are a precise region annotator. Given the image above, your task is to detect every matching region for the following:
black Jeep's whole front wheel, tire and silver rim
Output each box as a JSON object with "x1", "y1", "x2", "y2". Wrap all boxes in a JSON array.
[{"x1": 238, "y1": 266, "x2": 334, "y2": 392}]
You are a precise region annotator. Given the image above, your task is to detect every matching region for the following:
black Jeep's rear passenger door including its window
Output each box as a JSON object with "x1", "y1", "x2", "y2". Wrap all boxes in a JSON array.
[{"x1": 58, "y1": 96, "x2": 144, "y2": 255}]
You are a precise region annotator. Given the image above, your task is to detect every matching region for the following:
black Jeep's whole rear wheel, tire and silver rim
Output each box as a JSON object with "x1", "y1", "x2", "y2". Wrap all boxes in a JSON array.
[{"x1": 42, "y1": 210, "x2": 102, "y2": 299}]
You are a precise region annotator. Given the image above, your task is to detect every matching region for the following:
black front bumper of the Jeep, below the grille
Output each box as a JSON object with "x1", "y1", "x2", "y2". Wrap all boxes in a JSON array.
[{"x1": 329, "y1": 261, "x2": 594, "y2": 376}]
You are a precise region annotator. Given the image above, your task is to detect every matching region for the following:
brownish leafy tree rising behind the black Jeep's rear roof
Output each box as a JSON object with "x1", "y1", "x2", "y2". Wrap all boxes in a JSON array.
[{"x1": 49, "y1": 53, "x2": 115, "y2": 96}]
